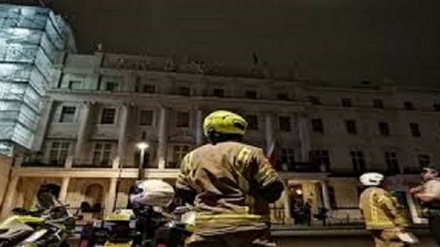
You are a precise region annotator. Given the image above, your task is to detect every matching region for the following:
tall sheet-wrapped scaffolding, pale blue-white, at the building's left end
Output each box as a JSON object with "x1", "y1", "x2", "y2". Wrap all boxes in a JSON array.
[{"x1": 0, "y1": 4, "x2": 76, "y2": 155}]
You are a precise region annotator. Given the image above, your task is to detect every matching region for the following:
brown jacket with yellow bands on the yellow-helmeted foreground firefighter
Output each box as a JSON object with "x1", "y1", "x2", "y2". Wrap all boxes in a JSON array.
[{"x1": 176, "y1": 141, "x2": 284, "y2": 235}]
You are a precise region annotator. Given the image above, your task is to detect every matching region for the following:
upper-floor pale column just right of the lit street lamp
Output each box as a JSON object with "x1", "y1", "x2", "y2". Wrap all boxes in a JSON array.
[{"x1": 157, "y1": 107, "x2": 169, "y2": 169}]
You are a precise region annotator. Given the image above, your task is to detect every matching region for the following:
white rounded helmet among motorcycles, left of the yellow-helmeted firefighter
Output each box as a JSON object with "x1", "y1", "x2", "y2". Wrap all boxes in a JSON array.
[{"x1": 130, "y1": 179, "x2": 174, "y2": 207}]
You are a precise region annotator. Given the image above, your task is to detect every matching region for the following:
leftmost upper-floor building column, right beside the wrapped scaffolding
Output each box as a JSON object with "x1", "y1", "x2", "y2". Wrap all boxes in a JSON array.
[{"x1": 32, "y1": 98, "x2": 54, "y2": 151}]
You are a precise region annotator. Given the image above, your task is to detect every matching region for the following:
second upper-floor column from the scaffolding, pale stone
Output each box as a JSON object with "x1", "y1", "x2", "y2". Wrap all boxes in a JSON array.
[{"x1": 74, "y1": 102, "x2": 91, "y2": 159}]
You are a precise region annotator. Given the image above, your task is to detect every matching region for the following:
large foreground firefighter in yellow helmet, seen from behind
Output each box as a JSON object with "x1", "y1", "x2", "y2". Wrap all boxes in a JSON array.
[{"x1": 176, "y1": 110, "x2": 284, "y2": 247}]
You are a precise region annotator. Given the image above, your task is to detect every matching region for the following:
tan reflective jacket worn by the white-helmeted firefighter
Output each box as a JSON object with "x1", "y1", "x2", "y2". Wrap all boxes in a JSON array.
[{"x1": 359, "y1": 187, "x2": 408, "y2": 230}]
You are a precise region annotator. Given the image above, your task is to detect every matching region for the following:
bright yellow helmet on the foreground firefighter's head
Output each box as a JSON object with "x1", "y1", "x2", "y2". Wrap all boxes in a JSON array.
[{"x1": 203, "y1": 110, "x2": 247, "y2": 136}]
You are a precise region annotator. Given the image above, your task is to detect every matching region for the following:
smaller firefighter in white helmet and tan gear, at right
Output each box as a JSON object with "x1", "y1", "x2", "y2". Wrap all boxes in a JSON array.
[{"x1": 359, "y1": 172, "x2": 408, "y2": 247}]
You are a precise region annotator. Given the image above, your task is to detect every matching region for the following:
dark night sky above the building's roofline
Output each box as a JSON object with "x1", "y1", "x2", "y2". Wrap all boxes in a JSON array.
[{"x1": 47, "y1": 0, "x2": 440, "y2": 85}]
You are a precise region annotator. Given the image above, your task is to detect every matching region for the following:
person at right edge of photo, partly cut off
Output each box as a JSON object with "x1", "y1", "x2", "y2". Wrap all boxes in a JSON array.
[{"x1": 410, "y1": 166, "x2": 440, "y2": 246}]
